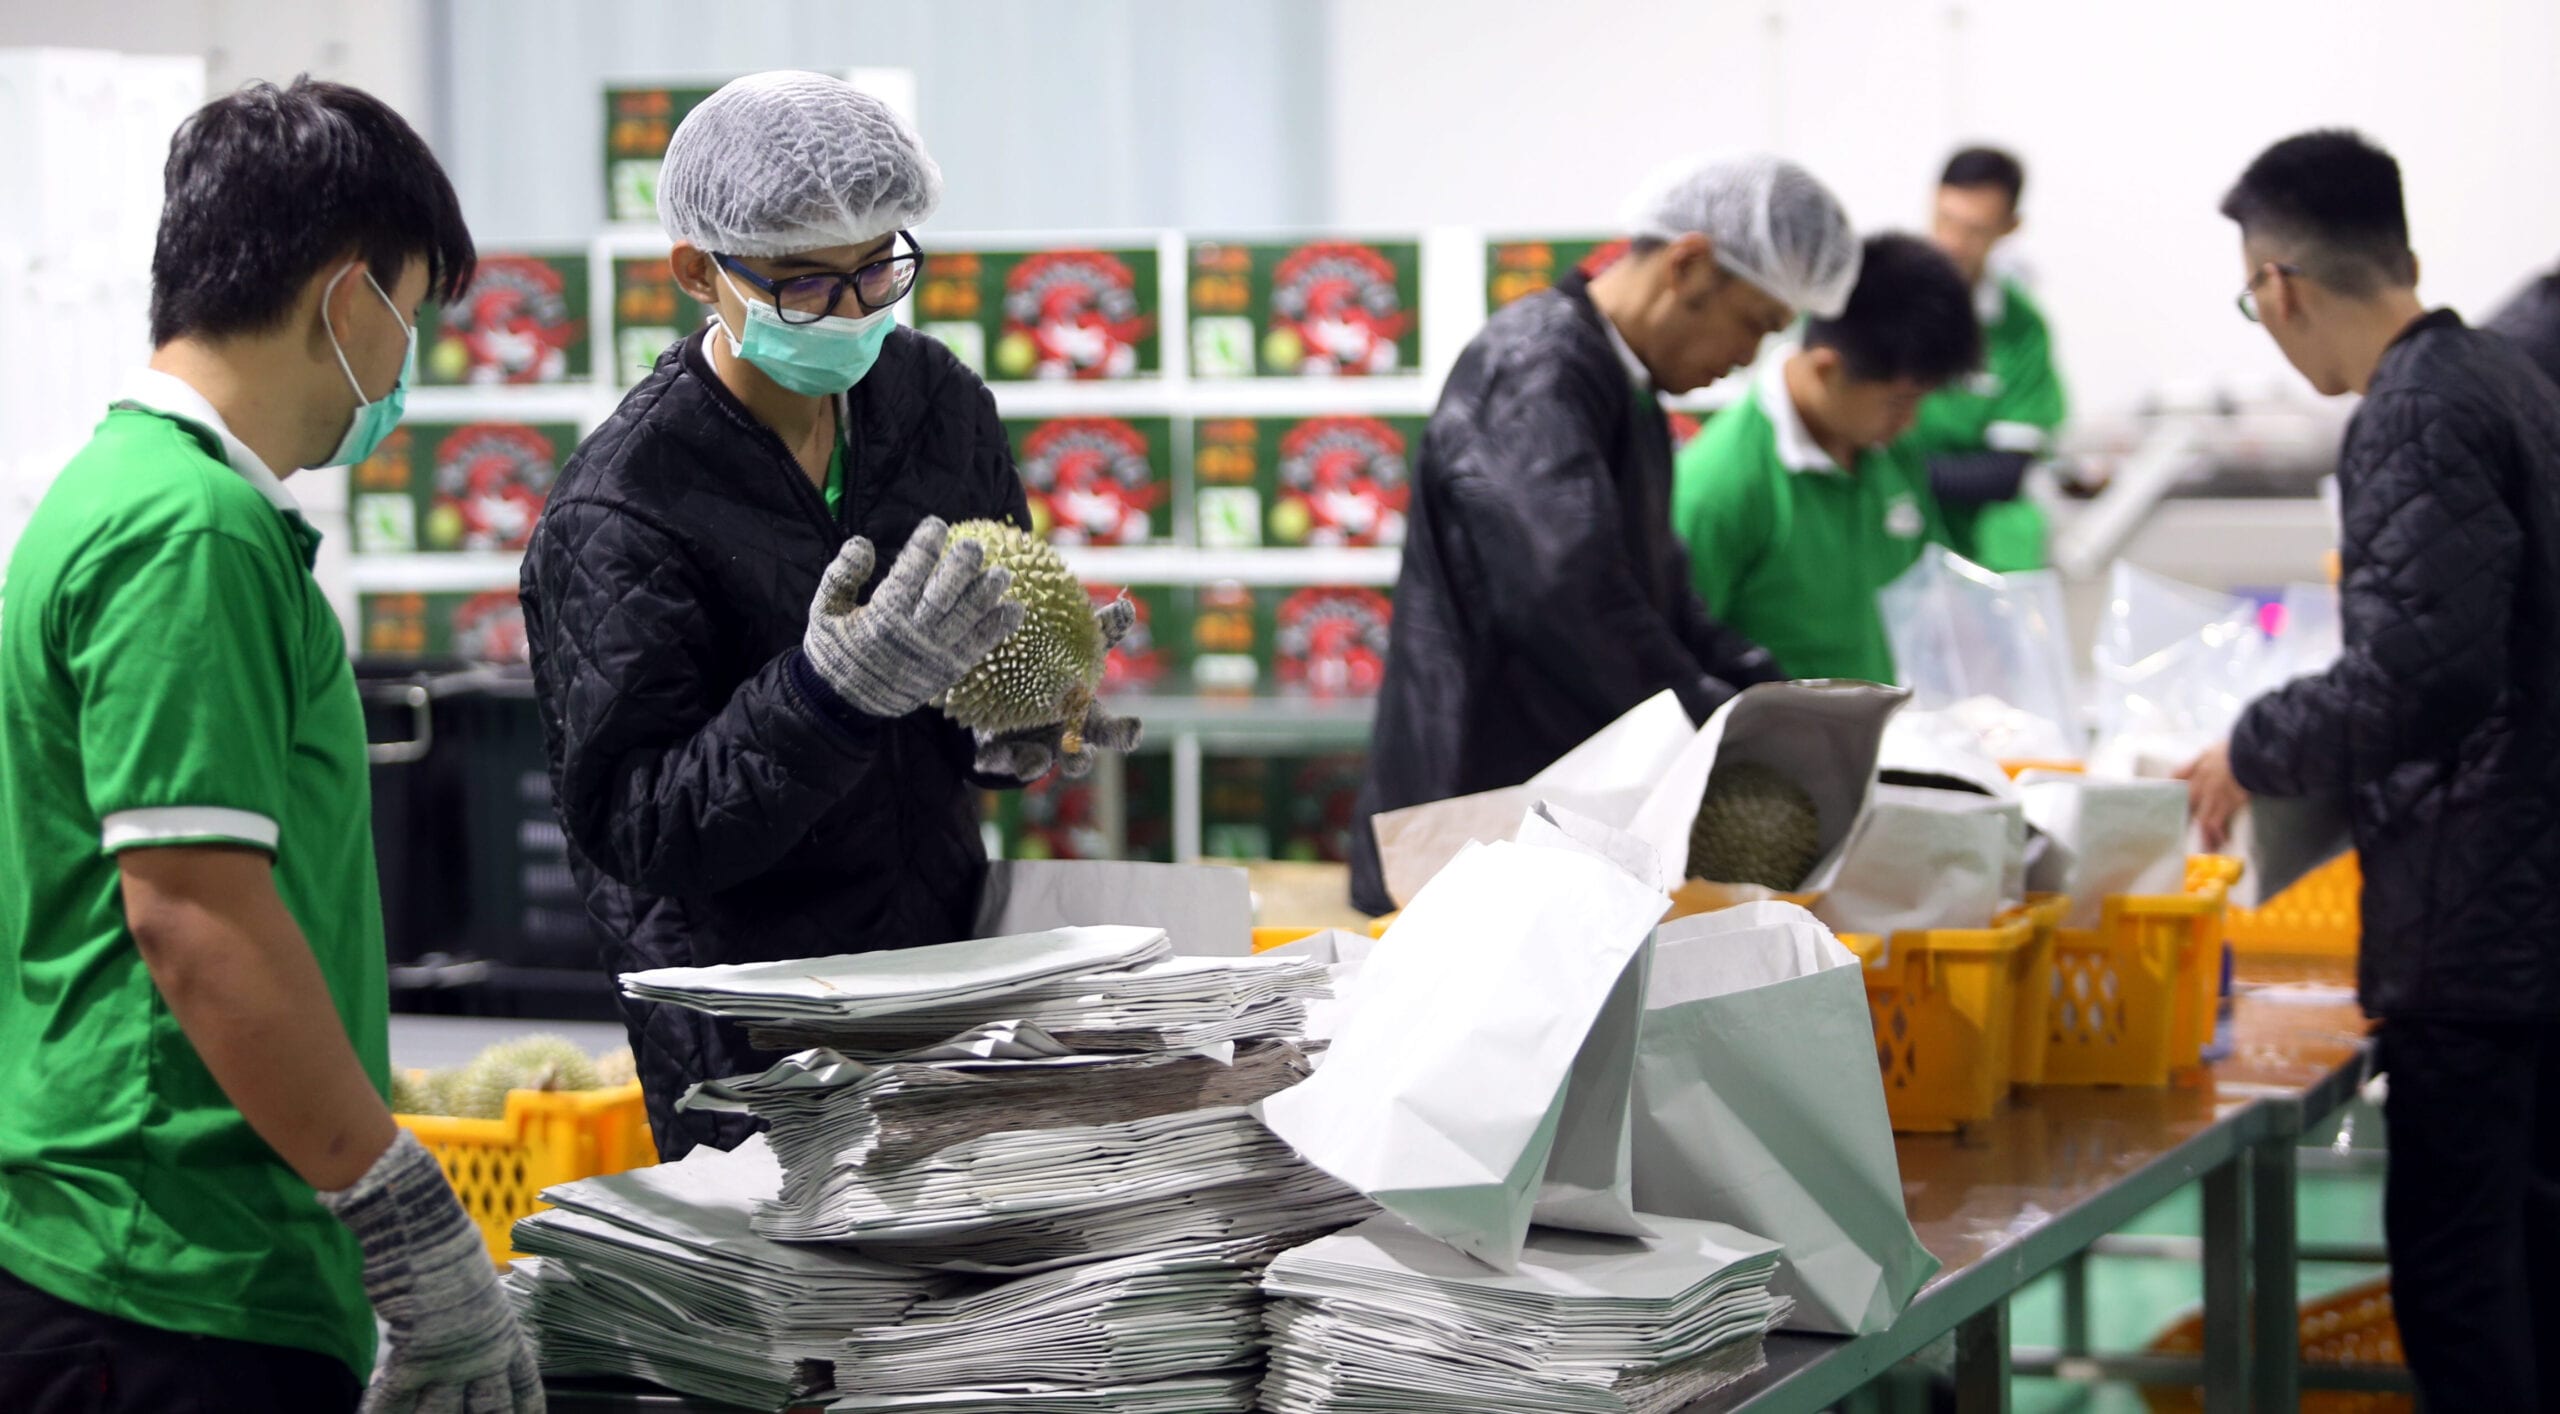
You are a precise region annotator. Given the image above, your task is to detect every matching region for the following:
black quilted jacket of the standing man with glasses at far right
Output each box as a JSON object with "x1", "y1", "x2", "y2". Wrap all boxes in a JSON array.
[{"x1": 2232, "y1": 310, "x2": 2560, "y2": 1020}]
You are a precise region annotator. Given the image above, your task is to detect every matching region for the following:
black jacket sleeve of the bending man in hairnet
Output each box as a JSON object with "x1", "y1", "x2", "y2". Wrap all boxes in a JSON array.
[{"x1": 1446, "y1": 366, "x2": 1733, "y2": 720}]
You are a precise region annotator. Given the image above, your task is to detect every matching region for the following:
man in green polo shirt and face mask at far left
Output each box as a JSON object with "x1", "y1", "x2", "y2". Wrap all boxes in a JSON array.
[{"x1": 0, "y1": 79, "x2": 543, "y2": 1414}]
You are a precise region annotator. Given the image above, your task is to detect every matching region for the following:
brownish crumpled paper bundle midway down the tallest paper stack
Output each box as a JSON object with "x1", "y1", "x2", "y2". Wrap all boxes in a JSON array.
[{"x1": 681, "y1": 1040, "x2": 1308, "y2": 1191}]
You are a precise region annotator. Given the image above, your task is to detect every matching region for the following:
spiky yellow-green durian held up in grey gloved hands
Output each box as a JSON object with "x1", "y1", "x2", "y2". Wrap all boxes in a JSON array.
[{"x1": 937, "y1": 520, "x2": 1108, "y2": 753}]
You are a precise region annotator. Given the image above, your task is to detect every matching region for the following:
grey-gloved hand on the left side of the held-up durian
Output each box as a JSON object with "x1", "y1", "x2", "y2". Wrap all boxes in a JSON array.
[{"x1": 801, "y1": 520, "x2": 1021, "y2": 717}]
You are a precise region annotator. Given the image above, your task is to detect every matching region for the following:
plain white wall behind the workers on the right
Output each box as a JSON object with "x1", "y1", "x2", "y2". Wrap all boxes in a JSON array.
[{"x1": 1329, "y1": 0, "x2": 2560, "y2": 410}]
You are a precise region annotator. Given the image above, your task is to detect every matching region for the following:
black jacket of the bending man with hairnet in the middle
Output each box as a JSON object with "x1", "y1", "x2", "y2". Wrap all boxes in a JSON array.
[{"x1": 1352, "y1": 274, "x2": 1779, "y2": 912}]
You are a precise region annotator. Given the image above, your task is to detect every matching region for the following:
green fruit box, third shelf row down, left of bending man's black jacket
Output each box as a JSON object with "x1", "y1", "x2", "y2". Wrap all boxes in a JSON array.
[{"x1": 1190, "y1": 584, "x2": 1395, "y2": 697}]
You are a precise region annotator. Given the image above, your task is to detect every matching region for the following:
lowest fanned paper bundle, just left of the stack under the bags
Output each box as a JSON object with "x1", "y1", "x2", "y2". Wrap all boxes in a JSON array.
[{"x1": 835, "y1": 1247, "x2": 1265, "y2": 1409}]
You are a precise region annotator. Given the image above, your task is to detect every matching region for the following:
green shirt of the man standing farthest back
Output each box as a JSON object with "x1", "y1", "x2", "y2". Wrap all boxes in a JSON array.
[{"x1": 1900, "y1": 277, "x2": 2066, "y2": 571}]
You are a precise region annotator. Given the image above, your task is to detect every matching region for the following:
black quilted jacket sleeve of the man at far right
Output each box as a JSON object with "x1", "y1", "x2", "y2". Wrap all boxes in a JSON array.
[{"x1": 2232, "y1": 392, "x2": 2524, "y2": 797}]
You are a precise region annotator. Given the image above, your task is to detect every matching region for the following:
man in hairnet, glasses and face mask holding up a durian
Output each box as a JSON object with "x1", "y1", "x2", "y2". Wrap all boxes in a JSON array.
[{"x1": 522, "y1": 72, "x2": 1139, "y2": 1158}]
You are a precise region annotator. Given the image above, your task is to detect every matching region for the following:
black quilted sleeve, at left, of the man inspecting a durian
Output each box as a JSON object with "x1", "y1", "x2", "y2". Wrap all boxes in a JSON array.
[{"x1": 525, "y1": 502, "x2": 883, "y2": 897}]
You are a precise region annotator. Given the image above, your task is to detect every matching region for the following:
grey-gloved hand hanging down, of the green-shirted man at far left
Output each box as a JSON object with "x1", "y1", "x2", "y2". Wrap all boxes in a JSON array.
[{"x1": 320, "y1": 1130, "x2": 543, "y2": 1414}]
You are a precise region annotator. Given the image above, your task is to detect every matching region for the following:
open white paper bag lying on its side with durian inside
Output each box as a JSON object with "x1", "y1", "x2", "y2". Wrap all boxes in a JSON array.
[{"x1": 1375, "y1": 681, "x2": 1910, "y2": 912}]
